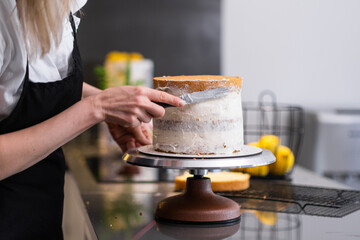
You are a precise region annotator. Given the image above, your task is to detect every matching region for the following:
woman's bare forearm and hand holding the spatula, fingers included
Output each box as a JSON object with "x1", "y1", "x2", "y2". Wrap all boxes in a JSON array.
[{"x1": 0, "y1": 83, "x2": 184, "y2": 180}]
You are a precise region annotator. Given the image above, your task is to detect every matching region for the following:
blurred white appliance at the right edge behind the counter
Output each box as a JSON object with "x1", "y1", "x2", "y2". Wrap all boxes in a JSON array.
[{"x1": 301, "y1": 109, "x2": 360, "y2": 189}]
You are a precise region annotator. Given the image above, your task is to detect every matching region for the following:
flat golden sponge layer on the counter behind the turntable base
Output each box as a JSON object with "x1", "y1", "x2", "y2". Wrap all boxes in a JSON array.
[{"x1": 175, "y1": 171, "x2": 250, "y2": 192}]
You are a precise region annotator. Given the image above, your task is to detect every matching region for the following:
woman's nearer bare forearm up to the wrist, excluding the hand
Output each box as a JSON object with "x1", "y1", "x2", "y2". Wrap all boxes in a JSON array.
[{"x1": 0, "y1": 95, "x2": 102, "y2": 180}]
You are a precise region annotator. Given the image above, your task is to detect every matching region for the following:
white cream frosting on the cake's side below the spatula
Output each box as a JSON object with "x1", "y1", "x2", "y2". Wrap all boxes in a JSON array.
[{"x1": 153, "y1": 91, "x2": 244, "y2": 154}]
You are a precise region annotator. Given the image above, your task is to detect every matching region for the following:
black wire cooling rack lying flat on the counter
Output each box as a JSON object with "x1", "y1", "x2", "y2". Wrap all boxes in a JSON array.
[{"x1": 218, "y1": 180, "x2": 360, "y2": 217}]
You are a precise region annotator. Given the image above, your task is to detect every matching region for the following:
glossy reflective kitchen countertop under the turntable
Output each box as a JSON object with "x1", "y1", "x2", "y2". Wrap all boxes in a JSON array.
[{"x1": 64, "y1": 135, "x2": 360, "y2": 240}]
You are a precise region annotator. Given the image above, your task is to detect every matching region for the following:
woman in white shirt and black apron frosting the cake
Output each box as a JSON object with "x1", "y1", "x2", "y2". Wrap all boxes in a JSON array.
[{"x1": 0, "y1": 0, "x2": 184, "y2": 239}]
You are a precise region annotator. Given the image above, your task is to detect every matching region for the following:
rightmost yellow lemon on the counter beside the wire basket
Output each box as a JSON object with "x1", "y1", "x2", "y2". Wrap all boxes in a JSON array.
[{"x1": 269, "y1": 145, "x2": 295, "y2": 175}]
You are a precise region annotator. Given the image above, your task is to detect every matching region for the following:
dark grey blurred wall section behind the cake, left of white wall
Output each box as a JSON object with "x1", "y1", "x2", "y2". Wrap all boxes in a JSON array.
[{"x1": 79, "y1": 0, "x2": 221, "y2": 81}]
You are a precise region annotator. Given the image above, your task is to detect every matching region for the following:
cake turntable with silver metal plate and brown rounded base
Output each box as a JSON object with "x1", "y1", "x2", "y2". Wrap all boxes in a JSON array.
[{"x1": 122, "y1": 145, "x2": 275, "y2": 224}]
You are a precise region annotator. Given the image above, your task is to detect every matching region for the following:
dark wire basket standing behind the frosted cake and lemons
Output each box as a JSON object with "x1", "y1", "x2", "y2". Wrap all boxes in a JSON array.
[{"x1": 243, "y1": 91, "x2": 304, "y2": 174}]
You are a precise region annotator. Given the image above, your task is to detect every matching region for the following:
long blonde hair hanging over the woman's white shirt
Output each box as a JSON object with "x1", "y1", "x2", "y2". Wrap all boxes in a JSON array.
[{"x1": 16, "y1": 0, "x2": 73, "y2": 57}]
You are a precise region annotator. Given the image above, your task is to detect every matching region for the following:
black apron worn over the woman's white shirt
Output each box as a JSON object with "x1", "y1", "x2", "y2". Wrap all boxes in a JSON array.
[{"x1": 0, "y1": 15, "x2": 82, "y2": 240}]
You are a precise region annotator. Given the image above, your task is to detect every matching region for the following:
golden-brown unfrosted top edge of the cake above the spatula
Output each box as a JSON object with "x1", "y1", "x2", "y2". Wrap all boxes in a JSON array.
[{"x1": 154, "y1": 75, "x2": 242, "y2": 93}]
